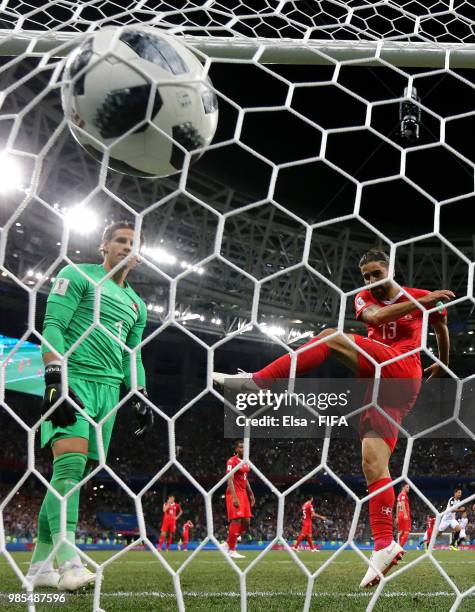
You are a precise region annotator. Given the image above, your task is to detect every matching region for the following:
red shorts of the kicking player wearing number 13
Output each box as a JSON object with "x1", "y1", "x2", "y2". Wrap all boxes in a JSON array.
[{"x1": 354, "y1": 334, "x2": 422, "y2": 452}]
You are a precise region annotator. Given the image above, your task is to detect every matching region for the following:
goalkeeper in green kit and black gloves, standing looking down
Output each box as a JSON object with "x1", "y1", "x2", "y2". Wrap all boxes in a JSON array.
[{"x1": 27, "y1": 222, "x2": 153, "y2": 591}]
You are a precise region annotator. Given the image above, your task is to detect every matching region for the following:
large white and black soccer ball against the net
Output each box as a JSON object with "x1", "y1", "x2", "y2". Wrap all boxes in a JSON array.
[{"x1": 61, "y1": 26, "x2": 218, "y2": 177}]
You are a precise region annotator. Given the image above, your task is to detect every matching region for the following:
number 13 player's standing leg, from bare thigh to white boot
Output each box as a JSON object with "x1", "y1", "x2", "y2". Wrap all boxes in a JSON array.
[{"x1": 360, "y1": 432, "x2": 404, "y2": 588}]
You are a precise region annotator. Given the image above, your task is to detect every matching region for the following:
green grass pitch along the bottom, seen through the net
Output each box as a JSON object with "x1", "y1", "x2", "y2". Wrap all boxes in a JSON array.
[{"x1": 0, "y1": 551, "x2": 475, "y2": 612}]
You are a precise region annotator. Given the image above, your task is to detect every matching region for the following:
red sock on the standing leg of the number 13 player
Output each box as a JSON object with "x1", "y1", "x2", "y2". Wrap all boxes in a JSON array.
[{"x1": 368, "y1": 478, "x2": 395, "y2": 550}]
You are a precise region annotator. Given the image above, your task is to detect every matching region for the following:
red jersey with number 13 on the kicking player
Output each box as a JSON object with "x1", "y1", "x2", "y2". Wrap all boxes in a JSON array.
[{"x1": 355, "y1": 287, "x2": 447, "y2": 353}]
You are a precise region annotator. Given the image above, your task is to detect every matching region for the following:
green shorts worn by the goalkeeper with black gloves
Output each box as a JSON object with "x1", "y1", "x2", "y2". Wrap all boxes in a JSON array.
[{"x1": 41, "y1": 378, "x2": 120, "y2": 461}]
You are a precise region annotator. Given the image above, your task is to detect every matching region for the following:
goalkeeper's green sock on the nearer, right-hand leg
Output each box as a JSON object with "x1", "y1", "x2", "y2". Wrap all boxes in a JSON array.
[{"x1": 44, "y1": 453, "x2": 87, "y2": 565}]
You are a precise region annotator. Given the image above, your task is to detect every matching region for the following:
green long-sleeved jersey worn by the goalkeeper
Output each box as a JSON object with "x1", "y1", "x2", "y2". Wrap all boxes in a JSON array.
[{"x1": 42, "y1": 264, "x2": 147, "y2": 387}]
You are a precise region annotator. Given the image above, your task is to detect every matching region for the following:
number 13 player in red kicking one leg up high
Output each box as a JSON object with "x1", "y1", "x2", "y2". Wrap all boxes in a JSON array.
[{"x1": 213, "y1": 250, "x2": 455, "y2": 587}]
